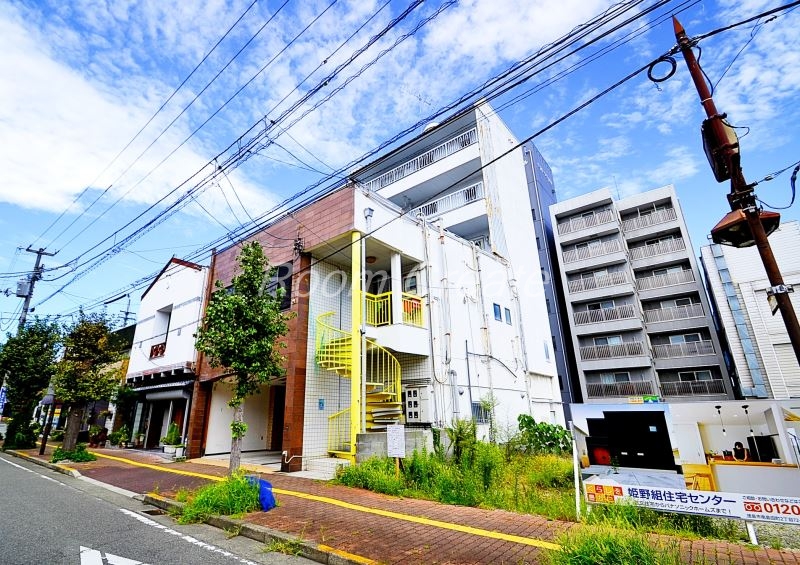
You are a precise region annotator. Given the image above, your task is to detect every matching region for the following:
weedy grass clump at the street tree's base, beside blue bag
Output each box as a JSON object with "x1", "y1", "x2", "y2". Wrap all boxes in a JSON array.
[{"x1": 176, "y1": 473, "x2": 261, "y2": 524}]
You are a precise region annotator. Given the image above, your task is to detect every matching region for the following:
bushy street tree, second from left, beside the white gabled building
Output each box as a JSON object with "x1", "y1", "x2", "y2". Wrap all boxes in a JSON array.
[{"x1": 53, "y1": 313, "x2": 120, "y2": 451}]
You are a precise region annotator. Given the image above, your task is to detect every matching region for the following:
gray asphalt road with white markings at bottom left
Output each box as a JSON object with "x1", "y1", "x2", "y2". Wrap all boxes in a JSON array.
[{"x1": 0, "y1": 454, "x2": 313, "y2": 565}]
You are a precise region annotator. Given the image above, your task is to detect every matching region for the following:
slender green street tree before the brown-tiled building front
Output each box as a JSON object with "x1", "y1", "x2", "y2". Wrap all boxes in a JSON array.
[{"x1": 195, "y1": 242, "x2": 289, "y2": 475}]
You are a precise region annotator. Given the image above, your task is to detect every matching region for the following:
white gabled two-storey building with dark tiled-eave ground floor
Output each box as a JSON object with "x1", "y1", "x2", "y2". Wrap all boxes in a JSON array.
[{"x1": 126, "y1": 257, "x2": 208, "y2": 449}]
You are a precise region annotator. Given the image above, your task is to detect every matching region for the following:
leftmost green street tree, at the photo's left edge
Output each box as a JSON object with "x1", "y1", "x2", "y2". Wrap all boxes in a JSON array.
[{"x1": 0, "y1": 319, "x2": 61, "y2": 449}]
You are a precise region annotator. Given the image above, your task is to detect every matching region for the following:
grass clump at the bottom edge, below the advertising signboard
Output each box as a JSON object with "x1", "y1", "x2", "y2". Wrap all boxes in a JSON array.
[{"x1": 546, "y1": 526, "x2": 692, "y2": 565}]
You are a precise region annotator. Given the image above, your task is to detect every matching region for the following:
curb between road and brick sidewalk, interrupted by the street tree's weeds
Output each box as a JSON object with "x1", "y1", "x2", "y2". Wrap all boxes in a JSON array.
[{"x1": 142, "y1": 494, "x2": 378, "y2": 565}]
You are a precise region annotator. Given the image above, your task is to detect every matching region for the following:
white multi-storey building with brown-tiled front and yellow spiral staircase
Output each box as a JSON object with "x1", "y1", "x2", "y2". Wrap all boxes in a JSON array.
[{"x1": 189, "y1": 100, "x2": 564, "y2": 471}]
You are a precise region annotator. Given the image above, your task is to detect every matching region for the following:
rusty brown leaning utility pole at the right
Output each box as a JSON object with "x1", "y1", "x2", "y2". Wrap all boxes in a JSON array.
[{"x1": 672, "y1": 17, "x2": 800, "y2": 363}]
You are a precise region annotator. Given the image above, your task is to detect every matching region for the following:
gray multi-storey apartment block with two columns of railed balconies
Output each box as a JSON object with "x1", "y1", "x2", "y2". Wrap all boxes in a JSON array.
[{"x1": 550, "y1": 185, "x2": 734, "y2": 402}]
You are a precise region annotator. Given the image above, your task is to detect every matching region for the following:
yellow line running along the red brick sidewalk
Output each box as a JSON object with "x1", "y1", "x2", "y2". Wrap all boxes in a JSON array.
[{"x1": 94, "y1": 452, "x2": 561, "y2": 550}]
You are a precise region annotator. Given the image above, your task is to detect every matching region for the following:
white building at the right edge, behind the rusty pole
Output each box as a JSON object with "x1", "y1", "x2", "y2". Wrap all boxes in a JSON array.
[{"x1": 700, "y1": 221, "x2": 800, "y2": 399}]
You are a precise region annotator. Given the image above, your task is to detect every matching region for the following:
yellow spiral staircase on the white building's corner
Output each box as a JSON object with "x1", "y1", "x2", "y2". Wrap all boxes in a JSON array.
[{"x1": 316, "y1": 312, "x2": 403, "y2": 457}]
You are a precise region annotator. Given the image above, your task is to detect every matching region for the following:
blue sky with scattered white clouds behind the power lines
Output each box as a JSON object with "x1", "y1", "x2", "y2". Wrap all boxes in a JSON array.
[{"x1": 0, "y1": 0, "x2": 800, "y2": 330}]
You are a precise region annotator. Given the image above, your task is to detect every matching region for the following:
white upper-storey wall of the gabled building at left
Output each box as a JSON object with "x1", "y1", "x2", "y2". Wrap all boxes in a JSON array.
[{"x1": 128, "y1": 263, "x2": 208, "y2": 375}]
